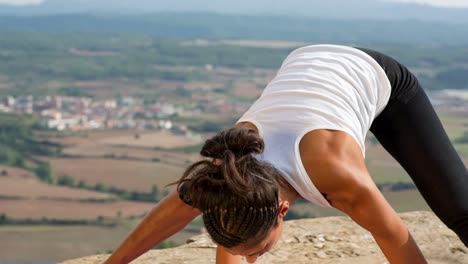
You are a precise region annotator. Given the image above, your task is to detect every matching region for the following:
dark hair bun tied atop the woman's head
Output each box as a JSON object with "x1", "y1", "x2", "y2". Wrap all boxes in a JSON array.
[{"x1": 200, "y1": 127, "x2": 264, "y2": 159}]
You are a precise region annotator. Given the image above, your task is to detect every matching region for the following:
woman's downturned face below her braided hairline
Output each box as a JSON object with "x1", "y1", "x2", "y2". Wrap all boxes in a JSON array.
[{"x1": 227, "y1": 219, "x2": 283, "y2": 263}]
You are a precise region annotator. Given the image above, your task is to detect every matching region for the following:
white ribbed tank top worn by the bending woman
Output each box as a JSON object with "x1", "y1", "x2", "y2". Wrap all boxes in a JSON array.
[{"x1": 238, "y1": 45, "x2": 391, "y2": 207}]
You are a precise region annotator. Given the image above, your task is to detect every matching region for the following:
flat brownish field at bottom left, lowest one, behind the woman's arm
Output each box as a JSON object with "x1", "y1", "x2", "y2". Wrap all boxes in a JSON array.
[{"x1": 0, "y1": 219, "x2": 200, "y2": 263}]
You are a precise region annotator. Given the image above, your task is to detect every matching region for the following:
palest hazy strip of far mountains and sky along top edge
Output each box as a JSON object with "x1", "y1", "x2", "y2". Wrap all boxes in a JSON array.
[{"x1": 0, "y1": 0, "x2": 468, "y2": 24}]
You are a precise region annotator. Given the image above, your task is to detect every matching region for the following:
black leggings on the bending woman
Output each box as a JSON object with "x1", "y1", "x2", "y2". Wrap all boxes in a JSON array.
[{"x1": 359, "y1": 48, "x2": 468, "y2": 246}]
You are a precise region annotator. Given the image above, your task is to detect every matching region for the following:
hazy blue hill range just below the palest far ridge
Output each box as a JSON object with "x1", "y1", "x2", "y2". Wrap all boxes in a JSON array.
[{"x1": 4, "y1": 13, "x2": 468, "y2": 47}]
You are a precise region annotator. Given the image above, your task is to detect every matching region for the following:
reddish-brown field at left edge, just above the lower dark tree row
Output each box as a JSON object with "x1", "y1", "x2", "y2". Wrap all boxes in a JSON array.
[{"x1": 0, "y1": 166, "x2": 154, "y2": 220}]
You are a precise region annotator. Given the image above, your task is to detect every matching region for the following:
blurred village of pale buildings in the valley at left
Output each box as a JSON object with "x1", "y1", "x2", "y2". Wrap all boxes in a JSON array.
[{"x1": 0, "y1": 96, "x2": 221, "y2": 134}]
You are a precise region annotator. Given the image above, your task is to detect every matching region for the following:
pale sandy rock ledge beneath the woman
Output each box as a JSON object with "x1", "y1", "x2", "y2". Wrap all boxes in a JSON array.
[{"x1": 63, "y1": 212, "x2": 468, "y2": 264}]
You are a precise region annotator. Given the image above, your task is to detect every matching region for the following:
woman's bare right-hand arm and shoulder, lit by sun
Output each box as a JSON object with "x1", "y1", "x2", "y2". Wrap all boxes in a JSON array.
[{"x1": 301, "y1": 130, "x2": 426, "y2": 264}]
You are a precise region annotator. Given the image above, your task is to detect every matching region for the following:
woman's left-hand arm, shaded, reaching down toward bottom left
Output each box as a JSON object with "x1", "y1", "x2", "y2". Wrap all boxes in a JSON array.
[{"x1": 105, "y1": 191, "x2": 200, "y2": 264}]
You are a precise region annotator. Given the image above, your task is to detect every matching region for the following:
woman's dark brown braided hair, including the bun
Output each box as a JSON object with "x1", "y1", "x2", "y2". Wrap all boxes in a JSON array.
[{"x1": 173, "y1": 128, "x2": 284, "y2": 248}]
